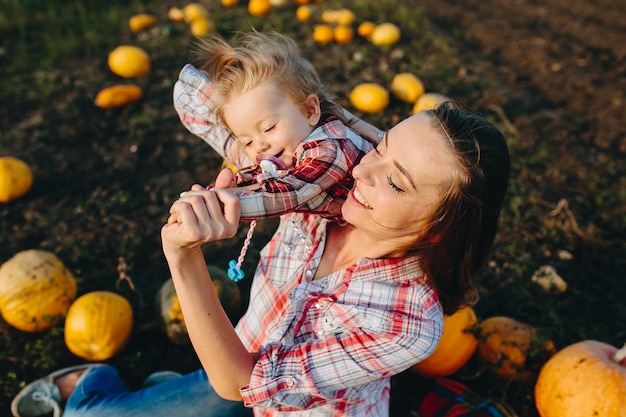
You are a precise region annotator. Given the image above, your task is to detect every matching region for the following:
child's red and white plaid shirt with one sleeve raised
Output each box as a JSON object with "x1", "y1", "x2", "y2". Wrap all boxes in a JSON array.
[{"x1": 174, "y1": 64, "x2": 372, "y2": 220}]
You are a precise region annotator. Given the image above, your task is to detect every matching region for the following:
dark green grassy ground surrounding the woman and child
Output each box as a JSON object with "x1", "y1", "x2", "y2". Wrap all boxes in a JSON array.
[{"x1": 0, "y1": 0, "x2": 626, "y2": 417}]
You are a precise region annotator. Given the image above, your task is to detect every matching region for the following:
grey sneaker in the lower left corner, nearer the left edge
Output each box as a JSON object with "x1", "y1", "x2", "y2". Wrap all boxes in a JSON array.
[{"x1": 11, "y1": 364, "x2": 101, "y2": 417}]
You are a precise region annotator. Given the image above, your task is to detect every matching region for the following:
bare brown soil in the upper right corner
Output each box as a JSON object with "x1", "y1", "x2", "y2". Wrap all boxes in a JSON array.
[{"x1": 420, "y1": 0, "x2": 626, "y2": 153}]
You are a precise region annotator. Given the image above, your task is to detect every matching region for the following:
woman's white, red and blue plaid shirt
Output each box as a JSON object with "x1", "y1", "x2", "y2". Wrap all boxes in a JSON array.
[{"x1": 236, "y1": 213, "x2": 443, "y2": 417}]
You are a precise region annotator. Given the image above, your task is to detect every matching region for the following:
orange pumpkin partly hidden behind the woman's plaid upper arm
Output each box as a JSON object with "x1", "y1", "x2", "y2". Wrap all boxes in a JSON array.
[{"x1": 411, "y1": 307, "x2": 478, "y2": 378}]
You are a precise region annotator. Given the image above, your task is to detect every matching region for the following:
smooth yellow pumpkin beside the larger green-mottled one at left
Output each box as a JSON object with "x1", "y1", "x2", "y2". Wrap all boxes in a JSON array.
[{"x1": 65, "y1": 291, "x2": 133, "y2": 361}]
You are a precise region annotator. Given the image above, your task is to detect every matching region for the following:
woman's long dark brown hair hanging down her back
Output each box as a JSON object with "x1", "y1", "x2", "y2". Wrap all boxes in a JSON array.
[{"x1": 417, "y1": 103, "x2": 510, "y2": 314}]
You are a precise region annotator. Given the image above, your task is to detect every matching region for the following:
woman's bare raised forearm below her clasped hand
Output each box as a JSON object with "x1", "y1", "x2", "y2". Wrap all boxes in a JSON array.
[{"x1": 166, "y1": 251, "x2": 256, "y2": 401}]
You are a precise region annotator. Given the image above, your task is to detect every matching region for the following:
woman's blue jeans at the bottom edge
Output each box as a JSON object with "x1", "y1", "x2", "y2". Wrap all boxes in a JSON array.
[{"x1": 63, "y1": 365, "x2": 252, "y2": 417}]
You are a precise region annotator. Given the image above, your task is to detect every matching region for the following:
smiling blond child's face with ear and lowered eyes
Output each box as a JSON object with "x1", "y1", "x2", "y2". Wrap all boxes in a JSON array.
[{"x1": 223, "y1": 81, "x2": 320, "y2": 168}]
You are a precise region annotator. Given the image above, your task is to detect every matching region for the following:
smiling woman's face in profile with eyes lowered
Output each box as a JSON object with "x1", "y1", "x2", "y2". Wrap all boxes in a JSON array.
[{"x1": 342, "y1": 113, "x2": 455, "y2": 248}]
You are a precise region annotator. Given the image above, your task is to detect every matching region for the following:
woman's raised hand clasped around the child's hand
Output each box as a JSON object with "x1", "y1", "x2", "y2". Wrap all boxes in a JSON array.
[{"x1": 161, "y1": 183, "x2": 241, "y2": 252}]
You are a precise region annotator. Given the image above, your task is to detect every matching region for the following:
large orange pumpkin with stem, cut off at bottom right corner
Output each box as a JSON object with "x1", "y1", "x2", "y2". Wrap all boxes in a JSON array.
[{"x1": 535, "y1": 340, "x2": 626, "y2": 417}]
